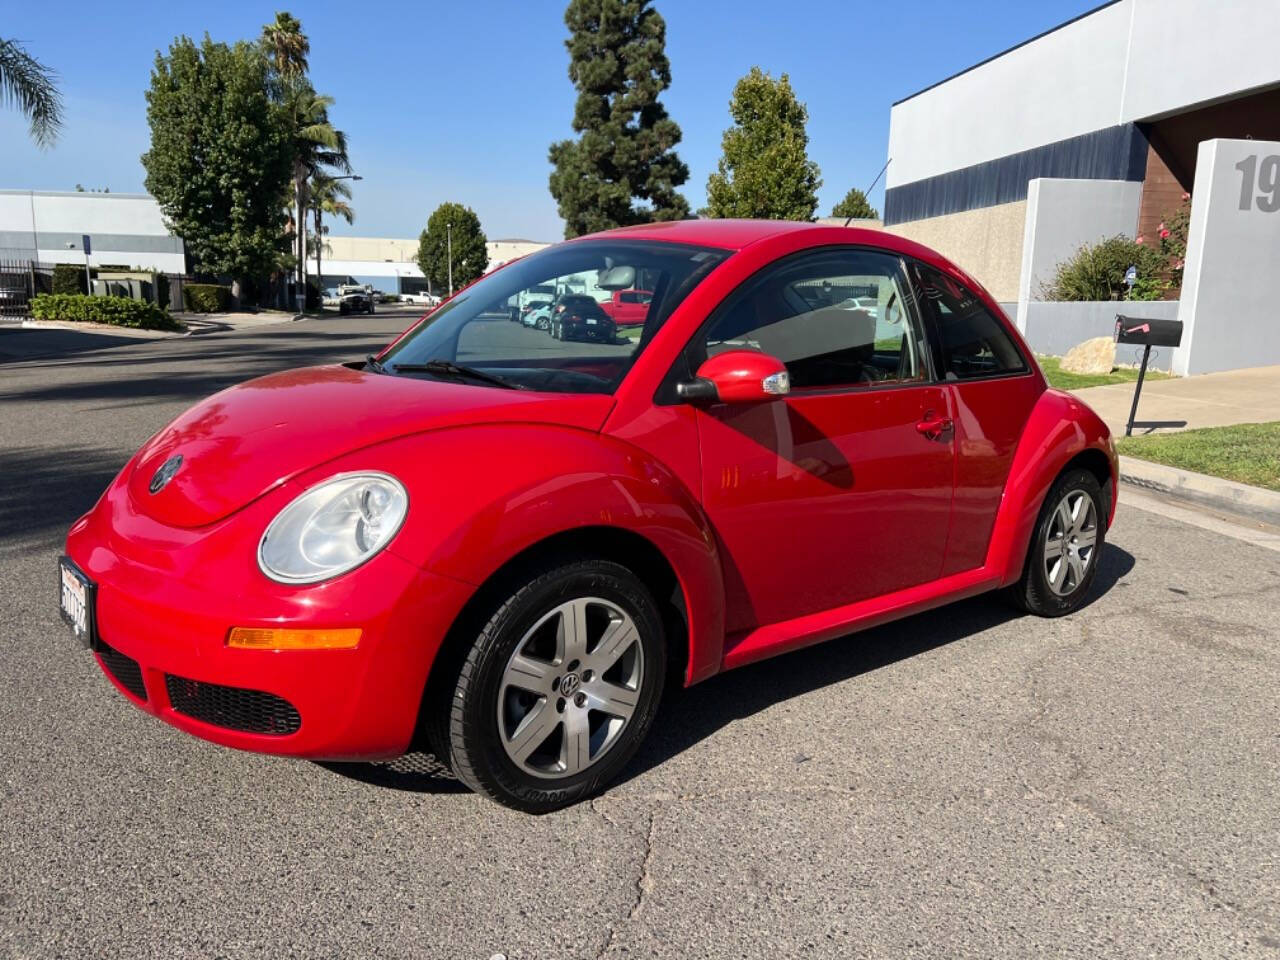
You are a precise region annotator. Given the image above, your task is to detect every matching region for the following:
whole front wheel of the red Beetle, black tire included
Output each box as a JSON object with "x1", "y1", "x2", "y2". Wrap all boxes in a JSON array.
[{"x1": 436, "y1": 559, "x2": 667, "y2": 813}]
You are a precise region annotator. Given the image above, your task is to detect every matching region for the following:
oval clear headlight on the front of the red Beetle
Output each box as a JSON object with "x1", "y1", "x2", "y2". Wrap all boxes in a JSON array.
[{"x1": 257, "y1": 474, "x2": 408, "y2": 584}]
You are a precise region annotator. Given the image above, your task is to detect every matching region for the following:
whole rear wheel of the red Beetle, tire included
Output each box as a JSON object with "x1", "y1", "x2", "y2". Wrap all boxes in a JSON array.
[{"x1": 1010, "y1": 470, "x2": 1107, "y2": 617}]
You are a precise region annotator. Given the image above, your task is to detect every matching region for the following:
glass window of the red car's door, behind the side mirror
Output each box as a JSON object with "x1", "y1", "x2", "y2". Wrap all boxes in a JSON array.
[{"x1": 691, "y1": 248, "x2": 928, "y2": 389}]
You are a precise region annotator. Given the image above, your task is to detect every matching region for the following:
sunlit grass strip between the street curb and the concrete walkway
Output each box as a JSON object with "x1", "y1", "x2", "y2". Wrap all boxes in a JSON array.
[{"x1": 1116, "y1": 421, "x2": 1280, "y2": 490}]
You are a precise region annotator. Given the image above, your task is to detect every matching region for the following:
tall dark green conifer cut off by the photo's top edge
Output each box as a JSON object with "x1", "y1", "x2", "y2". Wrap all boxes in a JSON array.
[{"x1": 549, "y1": 0, "x2": 689, "y2": 238}]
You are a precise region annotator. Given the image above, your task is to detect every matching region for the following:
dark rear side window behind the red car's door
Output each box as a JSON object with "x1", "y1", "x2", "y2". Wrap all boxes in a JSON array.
[{"x1": 915, "y1": 264, "x2": 1027, "y2": 380}]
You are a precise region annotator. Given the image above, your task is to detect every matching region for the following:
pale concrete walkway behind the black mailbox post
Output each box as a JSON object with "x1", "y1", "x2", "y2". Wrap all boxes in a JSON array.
[{"x1": 1073, "y1": 366, "x2": 1280, "y2": 436}]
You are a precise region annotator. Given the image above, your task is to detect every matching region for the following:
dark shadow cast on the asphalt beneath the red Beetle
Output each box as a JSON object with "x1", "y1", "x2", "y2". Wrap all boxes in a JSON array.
[{"x1": 325, "y1": 544, "x2": 1134, "y2": 794}]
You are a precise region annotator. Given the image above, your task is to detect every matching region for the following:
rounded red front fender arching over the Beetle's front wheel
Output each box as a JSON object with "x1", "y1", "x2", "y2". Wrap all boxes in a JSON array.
[{"x1": 300, "y1": 422, "x2": 724, "y2": 685}]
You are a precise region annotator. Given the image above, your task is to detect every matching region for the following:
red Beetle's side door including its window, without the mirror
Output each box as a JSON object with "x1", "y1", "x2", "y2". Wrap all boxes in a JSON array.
[{"x1": 686, "y1": 247, "x2": 954, "y2": 634}]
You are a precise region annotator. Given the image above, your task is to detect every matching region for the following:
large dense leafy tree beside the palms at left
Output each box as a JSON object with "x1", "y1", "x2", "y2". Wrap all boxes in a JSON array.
[{"x1": 142, "y1": 35, "x2": 291, "y2": 296}]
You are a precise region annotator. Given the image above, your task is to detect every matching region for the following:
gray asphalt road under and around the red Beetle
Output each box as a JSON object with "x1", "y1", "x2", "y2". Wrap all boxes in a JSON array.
[{"x1": 0, "y1": 314, "x2": 1280, "y2": 960}]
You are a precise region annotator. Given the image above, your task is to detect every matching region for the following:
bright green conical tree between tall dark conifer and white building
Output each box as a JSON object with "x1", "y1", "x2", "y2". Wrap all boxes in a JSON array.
[{"x1": 705, "y1": 67, "x2": 822, "y2": 220}]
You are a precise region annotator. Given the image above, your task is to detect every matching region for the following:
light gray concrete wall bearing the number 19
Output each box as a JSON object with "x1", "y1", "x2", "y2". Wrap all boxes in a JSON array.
[{"x1": 1175, "y1": 140, "x2": 1280, "y2": 374}]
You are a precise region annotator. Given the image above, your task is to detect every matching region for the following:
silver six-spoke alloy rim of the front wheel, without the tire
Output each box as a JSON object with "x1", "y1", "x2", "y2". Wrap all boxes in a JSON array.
[{"x1": 498, "y1": 596, "x2": 645, "y2": 778}]
